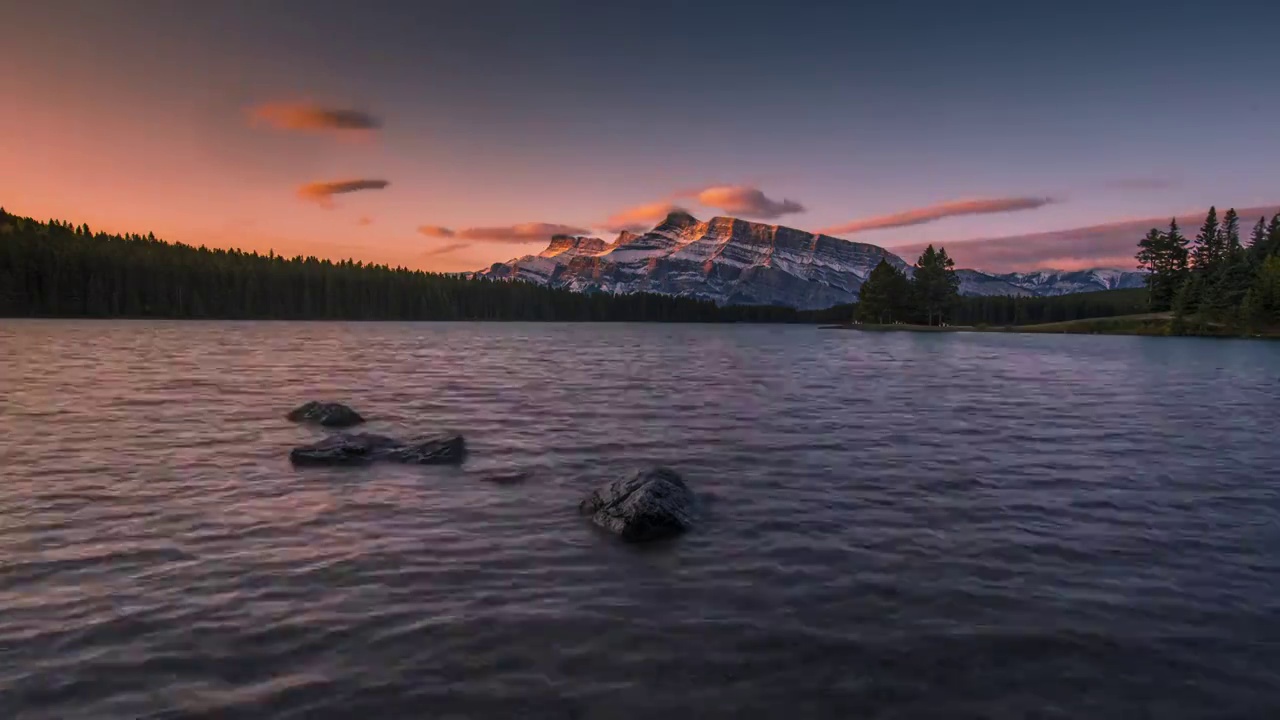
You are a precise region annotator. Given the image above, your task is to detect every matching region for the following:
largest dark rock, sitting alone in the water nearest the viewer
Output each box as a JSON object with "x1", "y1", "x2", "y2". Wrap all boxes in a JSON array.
[{"x1": 579, "y1": 468, "x2": 696, "y2": 542}]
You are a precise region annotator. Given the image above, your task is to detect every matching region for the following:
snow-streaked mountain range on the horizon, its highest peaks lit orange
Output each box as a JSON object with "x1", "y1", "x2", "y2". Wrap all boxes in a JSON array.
[{"x1": 477, "y1": 211, "x2": 1142, "y2": 310}]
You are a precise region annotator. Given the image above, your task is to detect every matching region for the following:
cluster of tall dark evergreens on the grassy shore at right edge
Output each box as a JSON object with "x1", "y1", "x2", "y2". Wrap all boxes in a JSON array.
[{"x1": 1137, "y1": 208, "x2": 1280, "y2": 334}]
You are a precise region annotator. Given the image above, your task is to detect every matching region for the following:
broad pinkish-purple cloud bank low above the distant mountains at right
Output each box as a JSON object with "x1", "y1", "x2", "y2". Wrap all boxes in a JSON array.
[{"x1": 890, "y1": 206, "x2": 1280, "y2": 273}]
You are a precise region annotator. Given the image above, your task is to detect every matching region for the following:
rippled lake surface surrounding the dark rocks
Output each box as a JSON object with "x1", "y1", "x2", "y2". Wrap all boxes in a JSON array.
[{"x1": 0, "y1": 322, "x2": 1280, "y2": 720}]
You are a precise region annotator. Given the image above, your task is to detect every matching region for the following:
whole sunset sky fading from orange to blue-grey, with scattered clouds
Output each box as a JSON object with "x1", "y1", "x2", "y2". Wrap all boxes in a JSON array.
[{"x1": 0, "y1": 0, "x2": 1280, "y2": 270}]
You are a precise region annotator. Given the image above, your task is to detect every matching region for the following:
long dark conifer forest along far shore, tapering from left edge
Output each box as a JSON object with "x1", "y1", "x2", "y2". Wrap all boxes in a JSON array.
[{"x1": 0, "y1": 209, "x2": 797, "y2": 322}]
